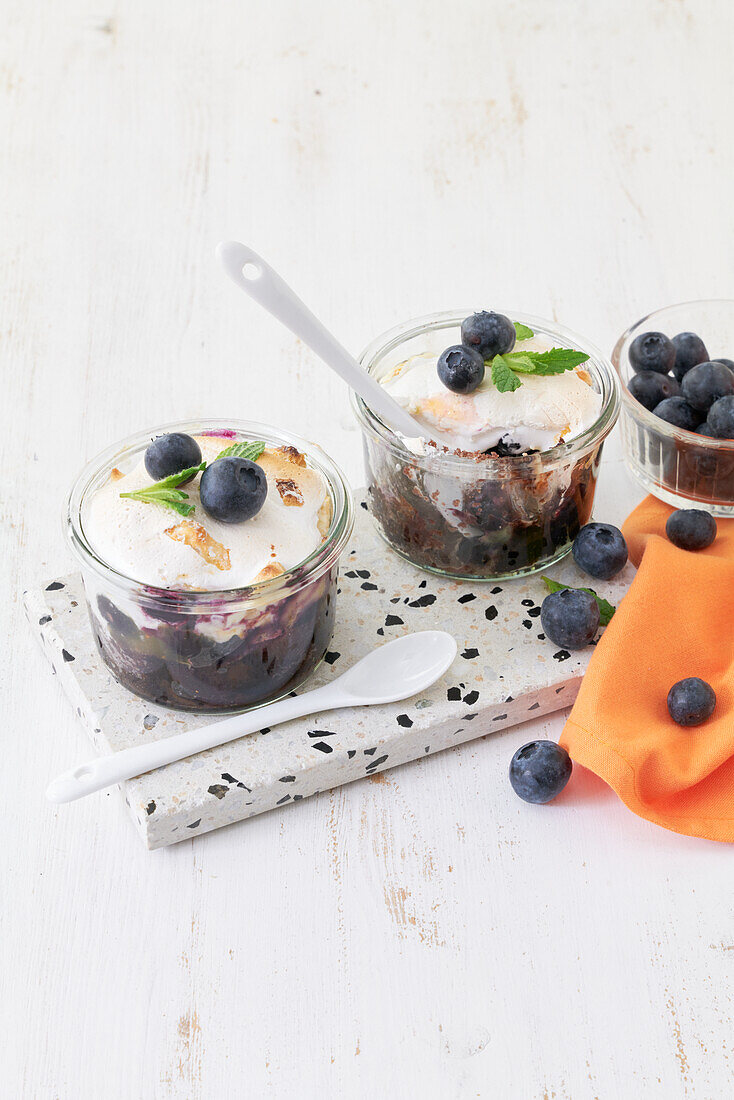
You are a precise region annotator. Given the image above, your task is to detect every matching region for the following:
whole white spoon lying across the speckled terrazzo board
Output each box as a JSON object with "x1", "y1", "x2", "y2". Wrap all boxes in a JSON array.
[{"x1": 46, "y1": 630, "x2": 457, "y2": 802}]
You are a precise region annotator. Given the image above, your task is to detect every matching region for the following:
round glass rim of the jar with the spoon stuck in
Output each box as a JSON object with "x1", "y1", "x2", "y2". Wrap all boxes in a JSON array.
[{"x1": 351, "y1": 309, "x2": 620, "y2": 476}]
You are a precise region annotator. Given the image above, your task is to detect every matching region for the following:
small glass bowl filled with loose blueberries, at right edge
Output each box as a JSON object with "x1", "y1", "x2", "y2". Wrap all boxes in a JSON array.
[{"x1": 612, "y1": 298, "x2": 734, "y2": 516}]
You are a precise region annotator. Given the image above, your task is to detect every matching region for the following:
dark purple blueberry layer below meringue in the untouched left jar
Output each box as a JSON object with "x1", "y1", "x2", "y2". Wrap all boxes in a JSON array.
[{"x1": 87, "y1": 565, "x2": 337, "y2": 712}]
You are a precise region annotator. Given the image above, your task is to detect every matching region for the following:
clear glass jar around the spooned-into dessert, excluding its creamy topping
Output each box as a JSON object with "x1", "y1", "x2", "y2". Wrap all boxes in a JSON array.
[{"x1": 352, "y1": 310, "x2": 620, "y2": 581}]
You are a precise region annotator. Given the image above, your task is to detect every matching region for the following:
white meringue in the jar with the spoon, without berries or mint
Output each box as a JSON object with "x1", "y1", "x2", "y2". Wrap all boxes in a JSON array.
[{"x1": 381, "y1": 337, "x2": 602, "y2": 454}]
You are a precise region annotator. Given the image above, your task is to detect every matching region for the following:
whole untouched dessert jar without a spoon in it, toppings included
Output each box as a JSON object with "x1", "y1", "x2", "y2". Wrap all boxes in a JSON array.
[{"x1": 65, "y1": 420, "x2": 353, "y2": 712}]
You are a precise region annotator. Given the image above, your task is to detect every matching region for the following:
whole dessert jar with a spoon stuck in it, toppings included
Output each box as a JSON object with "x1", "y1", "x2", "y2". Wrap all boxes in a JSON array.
[{"x1": 352, "y1": 311, "x2": 620, "y2": 581}]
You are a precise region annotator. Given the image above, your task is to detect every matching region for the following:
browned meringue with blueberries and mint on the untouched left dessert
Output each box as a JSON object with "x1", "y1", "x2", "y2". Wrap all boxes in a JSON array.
[{"x1": 83, "y1": 433, "x2": 331, "y2": 592}]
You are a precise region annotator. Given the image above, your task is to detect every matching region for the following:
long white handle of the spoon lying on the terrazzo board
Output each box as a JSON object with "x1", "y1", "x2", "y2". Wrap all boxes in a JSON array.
[{"x1": 46, "y1": 681, "x2": 344, "y2": 802}]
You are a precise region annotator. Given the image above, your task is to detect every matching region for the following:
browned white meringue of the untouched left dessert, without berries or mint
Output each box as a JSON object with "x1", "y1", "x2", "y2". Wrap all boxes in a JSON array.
[{"x1": 83, "y1": 435, "x2": 331, "y2": 592}]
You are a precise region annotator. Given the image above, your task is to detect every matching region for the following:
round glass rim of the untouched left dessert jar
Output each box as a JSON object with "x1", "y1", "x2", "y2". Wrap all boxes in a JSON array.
[{"x1": 64, "y1": 417, "x2": 354, "y2": 613}]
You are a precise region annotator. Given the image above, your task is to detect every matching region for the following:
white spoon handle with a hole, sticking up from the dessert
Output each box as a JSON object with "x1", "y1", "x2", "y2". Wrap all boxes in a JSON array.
[{"x1": 217, "y1": 241, "x2": 424, "y2": 438}]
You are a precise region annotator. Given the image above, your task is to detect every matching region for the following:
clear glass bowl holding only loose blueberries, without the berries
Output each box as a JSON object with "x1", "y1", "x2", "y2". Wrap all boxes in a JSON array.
[{"x1": 612, "y1": 298, "x2": 734, "y2": 516}]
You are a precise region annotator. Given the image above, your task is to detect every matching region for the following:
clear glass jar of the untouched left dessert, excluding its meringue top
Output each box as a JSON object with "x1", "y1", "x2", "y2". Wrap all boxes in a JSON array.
[{"x1": 65, "y1": 420, "x2": 354, "y2": 712}]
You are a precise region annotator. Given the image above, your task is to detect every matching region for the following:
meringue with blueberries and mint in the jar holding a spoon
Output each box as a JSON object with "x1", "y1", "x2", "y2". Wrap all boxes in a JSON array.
[{"x1": 381, "y1": 312, "x2": 602, "y2": 457}]
